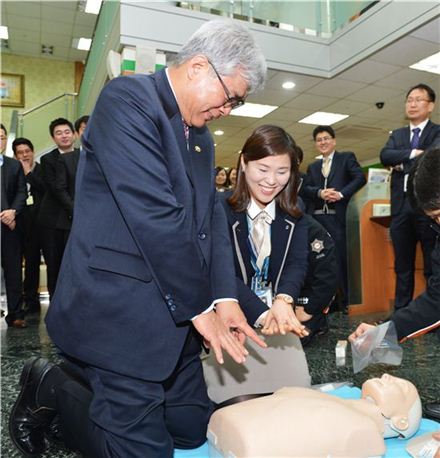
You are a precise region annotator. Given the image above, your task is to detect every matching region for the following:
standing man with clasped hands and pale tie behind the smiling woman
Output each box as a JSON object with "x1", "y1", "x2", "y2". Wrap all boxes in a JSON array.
[{"x1": 301, "y1": 126, "x2": 366, "y2": 310}]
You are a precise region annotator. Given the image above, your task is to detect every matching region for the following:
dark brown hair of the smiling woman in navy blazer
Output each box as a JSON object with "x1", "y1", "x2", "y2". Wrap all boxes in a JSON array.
[{"x1": 228, "y1": 125, "x2": 302, "y2": 217}]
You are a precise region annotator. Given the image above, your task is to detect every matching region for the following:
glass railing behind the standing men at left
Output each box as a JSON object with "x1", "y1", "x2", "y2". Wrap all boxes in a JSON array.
[{"x1": 16, "y1": 93, "x2": 77, "y2": 157}]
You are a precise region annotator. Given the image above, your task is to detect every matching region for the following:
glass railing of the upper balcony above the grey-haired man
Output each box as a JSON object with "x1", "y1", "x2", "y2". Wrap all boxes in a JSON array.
[{"x1": 176, "y1": 0, "x2": 378, "y2": 38}]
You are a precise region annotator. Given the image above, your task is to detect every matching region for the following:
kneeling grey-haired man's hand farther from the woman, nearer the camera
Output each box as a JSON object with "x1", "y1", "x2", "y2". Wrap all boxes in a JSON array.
[{"x1": 192, "y1": 310, "x2": 248, "y2": 364}]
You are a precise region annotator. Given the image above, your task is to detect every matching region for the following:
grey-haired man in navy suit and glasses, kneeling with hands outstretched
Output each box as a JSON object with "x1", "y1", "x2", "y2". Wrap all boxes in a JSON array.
[{"x1": 10, "y1": 20, "x2": 266, "y2": 458}]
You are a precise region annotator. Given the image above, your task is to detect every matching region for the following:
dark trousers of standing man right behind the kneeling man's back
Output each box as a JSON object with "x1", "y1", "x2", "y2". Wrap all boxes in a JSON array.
[{"x1": 41, "y1": 227, "x2": 66, "y2": 299}]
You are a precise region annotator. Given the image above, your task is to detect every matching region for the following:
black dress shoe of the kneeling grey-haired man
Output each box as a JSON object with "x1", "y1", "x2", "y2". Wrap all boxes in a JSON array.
[{"x1": 9, "y1": 358, "x2": 56, "y2": 457}]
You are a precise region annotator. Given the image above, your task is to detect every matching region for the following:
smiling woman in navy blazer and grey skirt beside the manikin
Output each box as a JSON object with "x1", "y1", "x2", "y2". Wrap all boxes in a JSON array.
[{"x1": 204, "y1": 125, "x2": 310, "y2": 403}]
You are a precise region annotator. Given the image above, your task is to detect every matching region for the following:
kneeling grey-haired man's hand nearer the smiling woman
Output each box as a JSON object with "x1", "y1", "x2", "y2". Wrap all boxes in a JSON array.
[{"x1": 215, "y1": 301, "x2": 267, "y2": 348}]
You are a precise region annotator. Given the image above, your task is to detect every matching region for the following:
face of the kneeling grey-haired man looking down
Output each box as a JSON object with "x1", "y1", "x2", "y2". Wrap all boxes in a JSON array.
[{"x1": 185, "y1": 61, "x2": 247, "y2": 127}]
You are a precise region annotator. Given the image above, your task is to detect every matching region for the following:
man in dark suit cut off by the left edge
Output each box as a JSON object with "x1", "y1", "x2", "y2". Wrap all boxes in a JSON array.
[{"x1": 0, "y1": 124, "x2": 26, "y2": 328}]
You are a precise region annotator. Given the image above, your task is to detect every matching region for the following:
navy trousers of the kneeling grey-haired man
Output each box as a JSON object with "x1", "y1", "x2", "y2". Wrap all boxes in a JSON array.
[{"x1": 51, "y1": 334, "x2": 212, "y2": 458}]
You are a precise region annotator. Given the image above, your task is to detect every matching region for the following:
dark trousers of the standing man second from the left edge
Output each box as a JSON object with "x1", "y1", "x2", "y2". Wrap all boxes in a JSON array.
[{"x1": 23, "y1": 222, "x2": 42, "y2": 309}]
